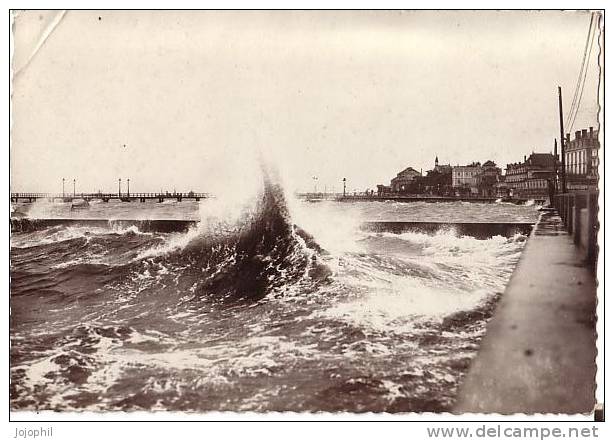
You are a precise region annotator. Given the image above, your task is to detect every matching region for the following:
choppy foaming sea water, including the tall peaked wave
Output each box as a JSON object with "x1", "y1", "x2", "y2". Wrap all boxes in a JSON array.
[{"x1": 10, "y1": 188, "x2": 537, "y2": 412}]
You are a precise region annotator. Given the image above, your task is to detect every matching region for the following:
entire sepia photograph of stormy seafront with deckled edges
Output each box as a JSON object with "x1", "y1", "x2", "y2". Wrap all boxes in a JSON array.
[{"x1": 6, "y1": 9, "x2": 605, "y2": 422}]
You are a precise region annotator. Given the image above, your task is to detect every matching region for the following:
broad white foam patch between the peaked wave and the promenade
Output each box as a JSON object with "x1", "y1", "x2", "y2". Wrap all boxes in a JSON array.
[{"x1": 323, "y1": 232, "x2": 522, "y2": 333}]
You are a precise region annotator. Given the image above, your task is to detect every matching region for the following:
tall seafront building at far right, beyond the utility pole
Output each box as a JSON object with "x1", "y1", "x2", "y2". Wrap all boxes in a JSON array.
[{"x1": 565, "y1": 127, "x2": 600, "y2": 191}]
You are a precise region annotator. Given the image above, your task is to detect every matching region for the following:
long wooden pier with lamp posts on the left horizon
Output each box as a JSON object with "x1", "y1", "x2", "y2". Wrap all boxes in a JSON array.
[{"x1": 11, "y1": 191, "x2": 212, "y2": 202}]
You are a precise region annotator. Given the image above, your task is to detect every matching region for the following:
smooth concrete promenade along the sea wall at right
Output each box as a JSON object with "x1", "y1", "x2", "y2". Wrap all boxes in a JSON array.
[{"x1": 453, "y1": 213, "x2": 597, "y2": 414}]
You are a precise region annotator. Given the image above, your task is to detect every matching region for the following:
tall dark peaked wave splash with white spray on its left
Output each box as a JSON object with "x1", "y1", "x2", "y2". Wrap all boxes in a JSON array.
[{"x1": 132, "y1": 167, "x2": 330, "y2": 300}]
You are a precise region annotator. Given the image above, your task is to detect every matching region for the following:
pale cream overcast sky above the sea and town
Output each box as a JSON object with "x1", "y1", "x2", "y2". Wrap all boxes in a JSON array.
[{"x1": 10, "y1": 11, "x2": 599, "y2": 194}]
